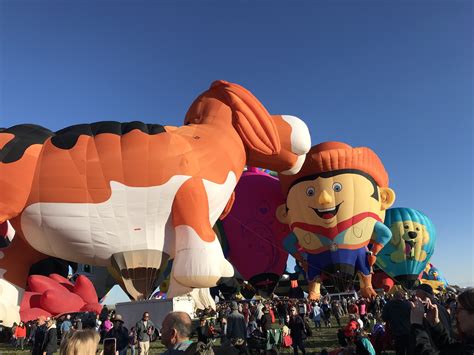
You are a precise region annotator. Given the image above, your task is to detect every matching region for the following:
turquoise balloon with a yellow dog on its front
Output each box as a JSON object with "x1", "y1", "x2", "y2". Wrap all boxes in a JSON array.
[{"x1": 377, "y1": 207, "x2": 436, "y2": 289}]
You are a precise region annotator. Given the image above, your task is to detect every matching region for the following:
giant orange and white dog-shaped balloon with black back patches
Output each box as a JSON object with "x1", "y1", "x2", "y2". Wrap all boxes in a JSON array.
[{"x1": 0, "y1": 81, "x2": 311, "y2": 310}]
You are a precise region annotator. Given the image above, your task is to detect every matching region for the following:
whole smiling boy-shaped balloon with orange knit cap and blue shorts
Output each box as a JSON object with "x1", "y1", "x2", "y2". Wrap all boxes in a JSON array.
[{"x1": 277, "y1": 142, "x2": 395, "y2": 299}]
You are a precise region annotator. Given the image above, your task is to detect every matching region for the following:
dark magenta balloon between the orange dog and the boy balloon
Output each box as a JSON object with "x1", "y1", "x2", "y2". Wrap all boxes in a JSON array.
[{"x1": 222, "y1": 168, "x2": 289, "y2": 297}]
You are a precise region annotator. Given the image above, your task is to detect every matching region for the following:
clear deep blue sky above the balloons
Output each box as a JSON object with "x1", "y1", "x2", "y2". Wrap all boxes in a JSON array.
[{"x1": 0, "y1": 0, "x2": 474, "y2": 285}]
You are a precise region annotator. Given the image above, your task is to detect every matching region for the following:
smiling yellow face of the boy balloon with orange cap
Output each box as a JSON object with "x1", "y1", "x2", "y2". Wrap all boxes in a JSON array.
[{"x1": 287, "y1": 173, "x2": 383, "y2": 253}]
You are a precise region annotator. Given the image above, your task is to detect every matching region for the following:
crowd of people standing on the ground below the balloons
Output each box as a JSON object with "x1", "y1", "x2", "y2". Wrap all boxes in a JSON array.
[{"x1": 1, "y1": 284, "x2": 474, "y2": 355}]
